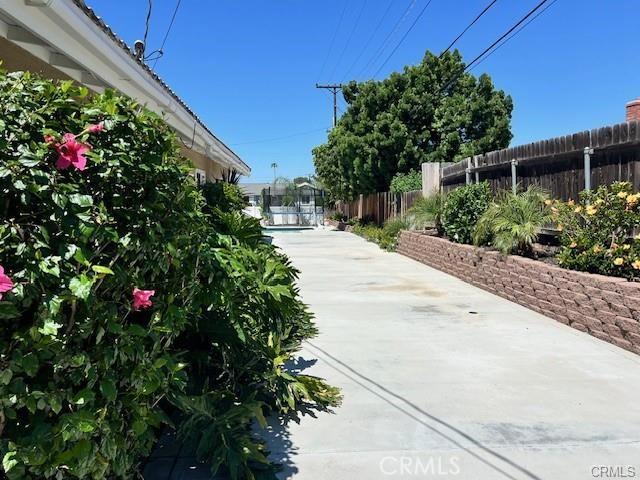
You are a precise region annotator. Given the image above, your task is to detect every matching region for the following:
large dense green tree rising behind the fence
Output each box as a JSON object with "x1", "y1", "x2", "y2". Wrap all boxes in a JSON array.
[{"x1": 313, "y1": 51, "x2": 513, "y2": 199}]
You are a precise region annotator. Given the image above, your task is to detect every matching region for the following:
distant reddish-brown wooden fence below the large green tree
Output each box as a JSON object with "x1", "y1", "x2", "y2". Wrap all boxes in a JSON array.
[{"x1": 336, "y1": 190, "x2": 422, "y2": 225}]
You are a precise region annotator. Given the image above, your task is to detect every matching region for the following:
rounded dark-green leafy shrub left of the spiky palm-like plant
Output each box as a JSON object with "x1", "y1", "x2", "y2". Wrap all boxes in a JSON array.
[{"x1": 442, "y1": 182, "x2": 491, "y2": 243}]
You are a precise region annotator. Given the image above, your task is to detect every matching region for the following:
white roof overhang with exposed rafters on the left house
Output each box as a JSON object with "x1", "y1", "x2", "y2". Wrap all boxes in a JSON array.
[{"x1": 0, "y1": 0, "x2": 251, "y2": 175}]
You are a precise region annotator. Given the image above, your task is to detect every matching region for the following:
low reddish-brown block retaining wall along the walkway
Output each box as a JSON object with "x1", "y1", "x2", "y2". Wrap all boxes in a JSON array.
[{"x1": 397, "y1": 231, "x2": 640, "y2": 354}]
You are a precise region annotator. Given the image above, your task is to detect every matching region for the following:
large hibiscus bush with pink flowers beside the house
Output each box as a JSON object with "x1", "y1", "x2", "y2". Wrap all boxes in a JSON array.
[{"x1": 0, "y1": 73, "x2": 339, "y2": 479}]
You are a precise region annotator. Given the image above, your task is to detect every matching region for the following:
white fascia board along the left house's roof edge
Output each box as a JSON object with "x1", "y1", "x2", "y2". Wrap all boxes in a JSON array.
[{"x1": 0, "y1": 0, "x2": 250, "y2": 175}]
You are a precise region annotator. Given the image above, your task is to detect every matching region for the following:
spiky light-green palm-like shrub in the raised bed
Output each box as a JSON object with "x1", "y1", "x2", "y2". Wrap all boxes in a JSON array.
[{"x1": 473, "y1": 185, "x2": 552, "y2": 255}]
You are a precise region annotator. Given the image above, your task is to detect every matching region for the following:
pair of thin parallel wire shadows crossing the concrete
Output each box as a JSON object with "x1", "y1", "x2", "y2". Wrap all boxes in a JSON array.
[{"x1": 305, "y1": 341, "x2": 542, "y2": 480}]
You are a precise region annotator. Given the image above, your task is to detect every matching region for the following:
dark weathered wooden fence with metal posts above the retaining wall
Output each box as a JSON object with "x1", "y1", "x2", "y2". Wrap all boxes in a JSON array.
[{"x1": 441, "y1": 121, "x2": 640, "y2": 200}]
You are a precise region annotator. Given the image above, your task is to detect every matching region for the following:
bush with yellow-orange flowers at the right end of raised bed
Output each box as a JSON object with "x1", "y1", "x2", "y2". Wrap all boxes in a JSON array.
[{"x1": 549, "y1": 182, "x2": 640, "y2": 279}]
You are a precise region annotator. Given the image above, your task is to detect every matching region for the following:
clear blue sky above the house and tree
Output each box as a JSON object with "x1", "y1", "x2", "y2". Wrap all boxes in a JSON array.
[{"x1": 87, "y1": 0, "x2": 640, "y2": 182}]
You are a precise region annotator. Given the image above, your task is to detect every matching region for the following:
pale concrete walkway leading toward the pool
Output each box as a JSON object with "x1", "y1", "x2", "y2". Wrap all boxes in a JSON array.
[{"x1": 270, "y1": 231, "x2": 640, "y2": 480}]
